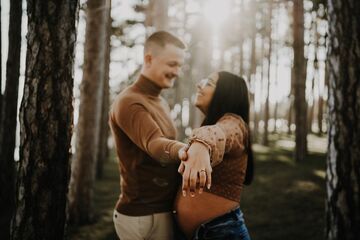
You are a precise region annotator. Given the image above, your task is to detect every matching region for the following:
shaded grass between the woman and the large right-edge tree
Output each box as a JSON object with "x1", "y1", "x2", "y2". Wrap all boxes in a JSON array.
[{"x1": 241, "y1": 136, "x2": 326, "y2": 240}]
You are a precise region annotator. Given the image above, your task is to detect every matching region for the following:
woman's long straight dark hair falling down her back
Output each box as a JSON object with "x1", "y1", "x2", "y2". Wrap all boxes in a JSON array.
[{"x1": 202, "y1": 71, "x2": 254, "y2": 185}]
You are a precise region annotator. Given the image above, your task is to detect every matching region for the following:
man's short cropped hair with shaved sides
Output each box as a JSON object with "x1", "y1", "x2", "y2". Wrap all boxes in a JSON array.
[{"x1": 144, "y1": 31, "x2": 186, "y2": 53}]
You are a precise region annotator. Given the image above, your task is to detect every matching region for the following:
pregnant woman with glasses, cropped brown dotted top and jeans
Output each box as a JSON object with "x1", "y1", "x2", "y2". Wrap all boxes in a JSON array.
[{"x1": 175, "y1": 72, "x2": 253, "y2": 240}]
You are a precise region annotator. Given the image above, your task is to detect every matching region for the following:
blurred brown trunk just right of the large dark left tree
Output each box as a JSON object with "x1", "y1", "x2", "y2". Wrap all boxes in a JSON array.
[{"x1": 69, "y1": 0, "x2": 109, "y2": 224}]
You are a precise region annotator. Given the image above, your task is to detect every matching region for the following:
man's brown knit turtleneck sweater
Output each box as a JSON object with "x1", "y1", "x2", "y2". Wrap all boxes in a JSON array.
[{"x1": 109, "y1": 75, "x2": 184, "y2": 216}]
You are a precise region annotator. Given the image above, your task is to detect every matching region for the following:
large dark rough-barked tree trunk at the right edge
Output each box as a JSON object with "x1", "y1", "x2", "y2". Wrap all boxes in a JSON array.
[{"x1": 325, "y1": 0, "x2": 360, "y2": 240}]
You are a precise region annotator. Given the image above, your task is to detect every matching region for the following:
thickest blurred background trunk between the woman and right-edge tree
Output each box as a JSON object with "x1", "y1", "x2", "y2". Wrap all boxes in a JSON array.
[{"x1": 293, "y1": 0, "x2": 307, "y2": 161}]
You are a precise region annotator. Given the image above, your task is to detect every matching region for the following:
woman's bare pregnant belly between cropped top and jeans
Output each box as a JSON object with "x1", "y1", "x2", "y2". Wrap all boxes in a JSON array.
[{"x1": 175, "y1": 191, "x2": 239, "y2": 238}]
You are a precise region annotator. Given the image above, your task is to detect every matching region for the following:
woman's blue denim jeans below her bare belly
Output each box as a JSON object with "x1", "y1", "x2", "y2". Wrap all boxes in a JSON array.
[{"x1": 175, "y1": 208, "x2": 250, "y2": 240}]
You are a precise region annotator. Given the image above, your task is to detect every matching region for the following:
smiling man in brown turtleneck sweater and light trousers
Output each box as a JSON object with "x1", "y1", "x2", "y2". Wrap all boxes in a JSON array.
[{"x1": 109, "y1": 31, "x2": 211, "y2": 240}]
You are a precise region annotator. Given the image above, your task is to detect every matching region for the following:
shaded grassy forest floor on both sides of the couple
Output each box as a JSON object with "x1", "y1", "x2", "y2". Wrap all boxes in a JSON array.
[{"x1": 69, "y1": 135, "x2": 327, "y2": 240}]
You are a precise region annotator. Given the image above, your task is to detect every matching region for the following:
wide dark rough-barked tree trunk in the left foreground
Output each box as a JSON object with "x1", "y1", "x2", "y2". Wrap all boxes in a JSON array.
[{"x1": 12, "y1": 0, "x2": 78, "y2": 240}]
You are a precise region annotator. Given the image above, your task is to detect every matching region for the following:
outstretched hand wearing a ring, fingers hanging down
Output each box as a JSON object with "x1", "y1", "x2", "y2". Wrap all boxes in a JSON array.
[{"x1": 178, "y1": 142, "x2": 212, "y2": 197}]
